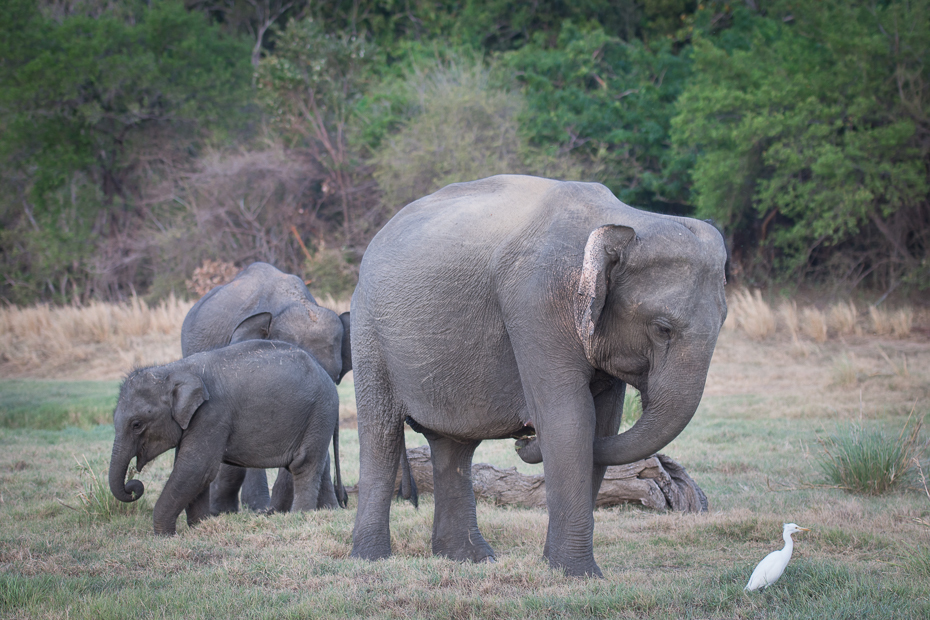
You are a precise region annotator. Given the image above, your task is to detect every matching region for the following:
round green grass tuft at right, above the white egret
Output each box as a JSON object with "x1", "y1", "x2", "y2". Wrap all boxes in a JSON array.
[{"x1": 820, "y1": 418, "x2": 924, "y2": 495}]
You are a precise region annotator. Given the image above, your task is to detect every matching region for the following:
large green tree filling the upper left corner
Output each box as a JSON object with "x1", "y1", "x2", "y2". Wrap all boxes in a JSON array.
[{"x1": 0, "y1": 0, "x2": 251, "y2": 301}]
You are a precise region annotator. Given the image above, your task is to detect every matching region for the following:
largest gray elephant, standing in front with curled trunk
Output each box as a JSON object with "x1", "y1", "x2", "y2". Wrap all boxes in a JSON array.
[{"x1": 352, "y1": 176, "x2": 726, "y2": 576}]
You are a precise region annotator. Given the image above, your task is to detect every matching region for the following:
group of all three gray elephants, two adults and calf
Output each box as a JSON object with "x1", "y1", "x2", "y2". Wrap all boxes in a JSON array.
[{"x1": 110, "y1": 175, "x2": 726, "y2": 576}]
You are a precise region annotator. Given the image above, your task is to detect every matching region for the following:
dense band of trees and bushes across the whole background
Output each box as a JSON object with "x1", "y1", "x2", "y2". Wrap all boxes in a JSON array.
[{"x1": 0, "y1": 0, "x2": 930, "y2": 303}]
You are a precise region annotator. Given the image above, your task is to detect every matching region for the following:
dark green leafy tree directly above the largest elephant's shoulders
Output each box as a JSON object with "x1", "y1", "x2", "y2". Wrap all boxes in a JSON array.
[{"x1": 503, "y1": 22, "x2": 690, "y2": 212}]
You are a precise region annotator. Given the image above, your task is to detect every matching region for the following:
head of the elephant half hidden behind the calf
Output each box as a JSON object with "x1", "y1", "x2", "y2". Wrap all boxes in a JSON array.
[{"x1": 230, "y1": 306, "x2": 352, "y2": 383}]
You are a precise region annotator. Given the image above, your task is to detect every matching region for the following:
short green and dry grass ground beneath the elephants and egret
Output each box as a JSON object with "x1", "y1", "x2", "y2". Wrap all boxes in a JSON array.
[{"x1": 0, "y1": 298, "x2": 930, "y2": 620}]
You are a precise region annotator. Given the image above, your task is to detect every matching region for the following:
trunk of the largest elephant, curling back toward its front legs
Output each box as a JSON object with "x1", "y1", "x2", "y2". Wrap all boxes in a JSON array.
[{"x1": 594, "y1": 369, "x2": 707, "y2": 466}]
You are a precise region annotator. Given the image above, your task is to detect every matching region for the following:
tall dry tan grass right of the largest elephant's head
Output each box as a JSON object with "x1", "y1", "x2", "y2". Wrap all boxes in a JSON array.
[{"x1": 726, "y1": 289, "x2": 916, "y2": 343}]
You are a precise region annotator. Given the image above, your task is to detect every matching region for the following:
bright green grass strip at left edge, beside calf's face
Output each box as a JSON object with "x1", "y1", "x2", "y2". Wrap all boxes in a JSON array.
[{"x1": 0, "y1": 379, "x2": 119, "y2": 430}]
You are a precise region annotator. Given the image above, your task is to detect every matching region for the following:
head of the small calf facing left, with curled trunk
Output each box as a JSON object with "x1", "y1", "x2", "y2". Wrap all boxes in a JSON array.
[{"x1": 109, "y1": 367, "x2": 210, "y2": 502}]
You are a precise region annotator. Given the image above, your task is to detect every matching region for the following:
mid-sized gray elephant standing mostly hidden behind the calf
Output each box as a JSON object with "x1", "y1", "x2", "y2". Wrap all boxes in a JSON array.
[{"x1": 181, "y1": 262, "x2": 352, "y2": 514}]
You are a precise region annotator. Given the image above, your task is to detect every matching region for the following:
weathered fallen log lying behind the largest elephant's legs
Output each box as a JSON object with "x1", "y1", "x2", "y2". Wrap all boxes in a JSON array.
[{"x1": 347, "y1": 446, "x2": 707, "y2": 512}]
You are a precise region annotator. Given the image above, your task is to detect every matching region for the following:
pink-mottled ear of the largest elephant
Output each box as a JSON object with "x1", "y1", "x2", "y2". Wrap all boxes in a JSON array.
[{"x1": 575, "y1": 224, "x2": 636, "y2": 357}]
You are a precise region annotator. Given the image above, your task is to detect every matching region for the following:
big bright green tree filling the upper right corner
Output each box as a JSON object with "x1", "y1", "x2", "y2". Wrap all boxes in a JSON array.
[{"x1": 673, "y1": 0, "x2": 930, "y2": 290}]
